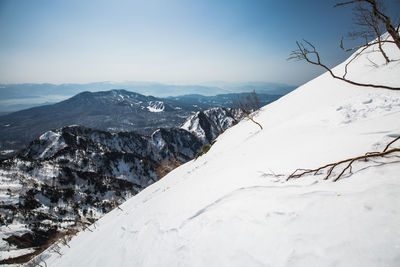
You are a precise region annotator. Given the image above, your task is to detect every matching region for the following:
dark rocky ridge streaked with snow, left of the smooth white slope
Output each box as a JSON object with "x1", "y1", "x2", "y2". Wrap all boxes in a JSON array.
[{"x1": 0, "y1": 106, "x2": 240, "y2": 264}]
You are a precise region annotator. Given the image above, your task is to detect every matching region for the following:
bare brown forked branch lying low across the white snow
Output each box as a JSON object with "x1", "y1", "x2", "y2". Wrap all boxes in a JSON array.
[{"x1": 286, "y1": 136, "x2": 400, "y2": 182}]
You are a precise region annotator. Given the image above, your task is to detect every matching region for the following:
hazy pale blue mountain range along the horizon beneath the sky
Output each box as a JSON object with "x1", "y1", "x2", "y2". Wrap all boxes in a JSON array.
[{"x1": 0, "y1": 82, "x2": 295, "y2": 113}]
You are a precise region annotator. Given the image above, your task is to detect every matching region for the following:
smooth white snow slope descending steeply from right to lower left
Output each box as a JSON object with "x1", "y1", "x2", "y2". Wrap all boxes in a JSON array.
[{"x1": 42, "y1": 43, "x2": 400, "y2": 267}]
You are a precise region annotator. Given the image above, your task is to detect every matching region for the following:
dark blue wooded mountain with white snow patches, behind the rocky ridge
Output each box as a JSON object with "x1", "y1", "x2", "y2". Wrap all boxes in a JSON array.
[{"x1": 0, "y1": 90, "x2": 280, "y2": 157}]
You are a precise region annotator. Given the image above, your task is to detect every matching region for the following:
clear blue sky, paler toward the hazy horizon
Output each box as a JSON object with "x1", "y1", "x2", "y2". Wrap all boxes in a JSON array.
[{"x1": 0, "y1": 0, "x2": 399, "y2": 85}]
